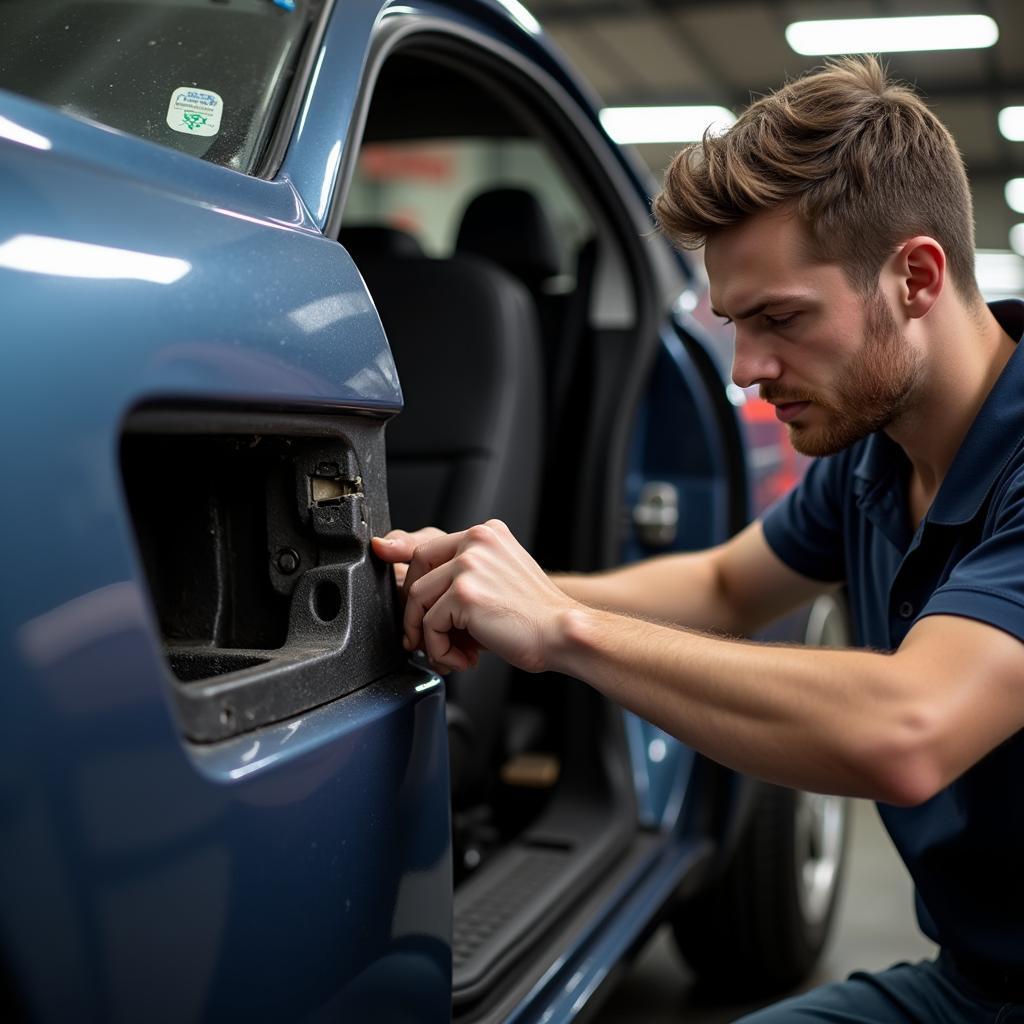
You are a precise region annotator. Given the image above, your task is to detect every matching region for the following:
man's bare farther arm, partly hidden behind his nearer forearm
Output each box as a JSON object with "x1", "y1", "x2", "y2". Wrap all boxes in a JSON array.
[{"x1": 551, "y1": 522, "x2": 831, "y2": 636}]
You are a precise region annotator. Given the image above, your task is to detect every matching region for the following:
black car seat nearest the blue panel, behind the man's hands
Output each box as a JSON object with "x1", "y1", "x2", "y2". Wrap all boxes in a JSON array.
[{"x1": 340, "y1": 227, "x2": 544, "y2": 805}]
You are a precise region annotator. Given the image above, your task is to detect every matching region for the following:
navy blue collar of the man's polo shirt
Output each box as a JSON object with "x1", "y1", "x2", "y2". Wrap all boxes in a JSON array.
[{"x1": 853, "y1": 299, "x2": 1024, "y2": 525}]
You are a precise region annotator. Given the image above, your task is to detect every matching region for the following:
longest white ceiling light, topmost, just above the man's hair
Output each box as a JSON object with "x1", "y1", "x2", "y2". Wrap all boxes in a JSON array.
[{"x1": 785, "y1": 14, "x2": 999, "y2": 56}]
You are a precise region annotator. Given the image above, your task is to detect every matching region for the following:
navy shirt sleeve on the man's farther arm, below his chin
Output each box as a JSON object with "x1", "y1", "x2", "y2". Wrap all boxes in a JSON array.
[{"x1": 762, "y1": 453, "x2": 849, "y2": 583}]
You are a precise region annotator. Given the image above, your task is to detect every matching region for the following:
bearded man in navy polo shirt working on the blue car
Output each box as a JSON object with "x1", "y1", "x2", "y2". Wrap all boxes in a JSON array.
[{"x1": 374, "y1": 58, "x2": 1024, "y2": 1022}]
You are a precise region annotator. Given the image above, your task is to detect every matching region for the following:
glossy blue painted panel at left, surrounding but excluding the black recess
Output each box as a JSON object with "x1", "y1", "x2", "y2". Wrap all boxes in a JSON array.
[{"x1": 0, "y1": 77, "x2": 451, "y2": 1022}]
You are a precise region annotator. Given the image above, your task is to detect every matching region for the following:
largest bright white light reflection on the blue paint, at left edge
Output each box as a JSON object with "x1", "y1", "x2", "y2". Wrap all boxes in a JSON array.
[{"x1": 0, "y1": 234, "x2": 191, "y2": 285}]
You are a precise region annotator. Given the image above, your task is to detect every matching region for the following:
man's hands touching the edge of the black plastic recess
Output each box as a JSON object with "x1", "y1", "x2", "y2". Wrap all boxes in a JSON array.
[{"x1": 374, "y1": 519, "x2": 578, "y2": 672}]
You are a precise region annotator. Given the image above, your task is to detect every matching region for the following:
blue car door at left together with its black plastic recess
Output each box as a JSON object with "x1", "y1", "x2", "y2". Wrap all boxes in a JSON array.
[{"x1": 0, "y1": 5, "x2": 451, "y2": 1022}]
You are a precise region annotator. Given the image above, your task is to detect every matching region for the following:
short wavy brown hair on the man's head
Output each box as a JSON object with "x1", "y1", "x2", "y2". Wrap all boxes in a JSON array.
[{"x1": 654, "y1": 56, "x2": 978, "y2": 302}]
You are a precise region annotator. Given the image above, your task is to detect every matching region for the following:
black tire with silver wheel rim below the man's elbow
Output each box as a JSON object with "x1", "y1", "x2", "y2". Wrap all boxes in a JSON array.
[{"x1": 673, "y1": 596, "x2": 850, "y2": 999}]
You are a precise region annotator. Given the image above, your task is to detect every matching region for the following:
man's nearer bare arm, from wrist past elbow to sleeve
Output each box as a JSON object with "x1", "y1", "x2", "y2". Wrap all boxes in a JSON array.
[{"x1": 549, "y1": 608, "x2": 1024, "y2": 805}]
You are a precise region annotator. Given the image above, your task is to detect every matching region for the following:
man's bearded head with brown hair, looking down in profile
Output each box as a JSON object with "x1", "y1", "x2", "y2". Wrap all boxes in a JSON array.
[{"x1": 654, "y1": 57, "x2": 984, "y2": 455}]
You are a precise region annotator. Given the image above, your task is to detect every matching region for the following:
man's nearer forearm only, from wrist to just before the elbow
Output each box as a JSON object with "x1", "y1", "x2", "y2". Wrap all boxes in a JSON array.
[{"x1": 550, "y1": 609, "x2": 927, "y2": 803}]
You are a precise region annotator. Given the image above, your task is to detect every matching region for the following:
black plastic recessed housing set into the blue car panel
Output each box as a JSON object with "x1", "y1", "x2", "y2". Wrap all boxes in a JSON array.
[{"x1": 122, "y1": 410, "x2": 407, "y2": 742}]
